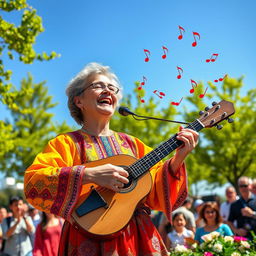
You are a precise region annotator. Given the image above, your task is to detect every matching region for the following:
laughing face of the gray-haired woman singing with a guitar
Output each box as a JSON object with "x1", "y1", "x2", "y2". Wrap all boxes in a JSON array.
[{"x1": 75, "y1": 75, "x2": 118, "y2": 121}]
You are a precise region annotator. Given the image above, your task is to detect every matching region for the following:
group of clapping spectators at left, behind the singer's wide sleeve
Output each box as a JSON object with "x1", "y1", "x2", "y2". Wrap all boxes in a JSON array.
[{"x1": 0, "y1": 196, "x2": 63, "y2": 256}]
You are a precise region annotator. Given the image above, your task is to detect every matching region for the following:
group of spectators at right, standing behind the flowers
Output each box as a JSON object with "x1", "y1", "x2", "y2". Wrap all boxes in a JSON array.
[{"x1": 154, "y1": 176, "x2": 256, "y2": 251}]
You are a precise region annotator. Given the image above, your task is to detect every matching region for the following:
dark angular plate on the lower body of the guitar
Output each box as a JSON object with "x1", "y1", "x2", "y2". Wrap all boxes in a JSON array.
[{"x1": 75, "y1": 186, "x2": 108, "y2": 217}]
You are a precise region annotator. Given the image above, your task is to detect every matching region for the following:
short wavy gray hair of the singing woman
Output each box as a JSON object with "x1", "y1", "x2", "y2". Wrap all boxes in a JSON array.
[{"x1": 66, "y1": 62, "x2": 123, "y2": 125}]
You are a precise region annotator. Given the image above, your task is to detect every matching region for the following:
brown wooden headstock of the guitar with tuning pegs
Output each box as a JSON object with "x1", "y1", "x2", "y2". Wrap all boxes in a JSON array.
[{"x1": 198, "y1": 100, "x2": 235, "y2": 129}]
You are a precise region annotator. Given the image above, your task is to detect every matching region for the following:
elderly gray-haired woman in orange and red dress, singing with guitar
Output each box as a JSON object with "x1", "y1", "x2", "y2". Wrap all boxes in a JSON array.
[{"x1": 25, "y1": 63, "x2": 198, "y2": 256}]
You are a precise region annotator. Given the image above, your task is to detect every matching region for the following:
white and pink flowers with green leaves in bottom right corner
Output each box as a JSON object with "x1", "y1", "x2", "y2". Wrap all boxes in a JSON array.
[{"x1": 170, "y1": 232, "x2": 256, "y2": 256}]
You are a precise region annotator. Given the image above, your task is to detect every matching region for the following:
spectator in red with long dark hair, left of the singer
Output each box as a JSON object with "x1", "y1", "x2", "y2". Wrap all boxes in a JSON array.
[{"x1": 33, "y1": 212, "x2": 62, "y2": 256}]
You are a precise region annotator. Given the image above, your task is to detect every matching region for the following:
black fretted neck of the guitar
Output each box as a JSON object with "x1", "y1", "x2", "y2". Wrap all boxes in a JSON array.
[{"x1": 129, "y1": 119, "x2": 204, "y2": 179}]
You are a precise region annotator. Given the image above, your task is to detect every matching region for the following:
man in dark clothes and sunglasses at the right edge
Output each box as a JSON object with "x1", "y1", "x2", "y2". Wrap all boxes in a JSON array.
[{"x1": 228, "y1": 176, "x2": 256, "y2": 238}]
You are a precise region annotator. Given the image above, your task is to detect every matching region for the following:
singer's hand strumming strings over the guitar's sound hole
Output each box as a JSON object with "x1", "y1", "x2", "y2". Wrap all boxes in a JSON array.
[{"x1": 83, "y1": 164, "x2": 129, "y2": 192}]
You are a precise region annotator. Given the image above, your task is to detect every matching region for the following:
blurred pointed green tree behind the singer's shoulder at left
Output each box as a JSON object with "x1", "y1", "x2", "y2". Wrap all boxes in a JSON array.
[{"x1": 0, "y1": 75, "x2": 71, "y2": 175}]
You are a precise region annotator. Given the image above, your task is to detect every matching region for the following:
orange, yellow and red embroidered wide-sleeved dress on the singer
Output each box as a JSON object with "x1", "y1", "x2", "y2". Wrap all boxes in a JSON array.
[{"x1": 24, "y1": 131, "x2": 187, "y2": 256}]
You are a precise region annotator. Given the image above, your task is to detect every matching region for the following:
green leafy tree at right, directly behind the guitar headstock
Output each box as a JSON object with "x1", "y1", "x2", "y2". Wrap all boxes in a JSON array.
[{"x1": 183, "y1": 77, "x2": 256, "y2": 191}]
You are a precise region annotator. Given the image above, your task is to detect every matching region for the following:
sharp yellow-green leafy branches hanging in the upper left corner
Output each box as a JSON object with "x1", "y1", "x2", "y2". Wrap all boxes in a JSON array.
[{"x1": 0, "y1": 0, "x2": 58, "y2": 157}]
